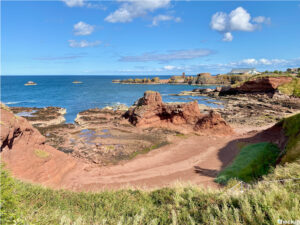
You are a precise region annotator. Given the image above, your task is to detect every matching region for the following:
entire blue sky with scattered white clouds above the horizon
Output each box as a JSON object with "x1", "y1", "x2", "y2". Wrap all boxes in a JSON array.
[{"x1": 1, "y1": 0, "x2": 300, "y2": 75}]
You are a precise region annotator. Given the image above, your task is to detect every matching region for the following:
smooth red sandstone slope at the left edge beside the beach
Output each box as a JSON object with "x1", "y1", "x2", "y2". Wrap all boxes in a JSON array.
[{"x1": 0, "y1": 104, "x2": 75, "y2": 184}]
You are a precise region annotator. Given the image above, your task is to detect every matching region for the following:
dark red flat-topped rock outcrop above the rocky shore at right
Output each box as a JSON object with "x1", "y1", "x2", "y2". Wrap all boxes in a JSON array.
[{"x1": 220, "y1": 76, "x2": 292, "y2": 96}]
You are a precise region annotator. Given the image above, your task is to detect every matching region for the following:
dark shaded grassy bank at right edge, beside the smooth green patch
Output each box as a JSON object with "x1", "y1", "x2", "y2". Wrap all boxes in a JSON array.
[{"x1": 280, "y1": 113, "x2": 300, "y2": 163}]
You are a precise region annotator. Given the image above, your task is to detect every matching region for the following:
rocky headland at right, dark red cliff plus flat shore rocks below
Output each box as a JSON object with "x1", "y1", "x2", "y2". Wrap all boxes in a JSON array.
[{"x1": 178, "y1": 76, "x2": 300, "y2": 127}]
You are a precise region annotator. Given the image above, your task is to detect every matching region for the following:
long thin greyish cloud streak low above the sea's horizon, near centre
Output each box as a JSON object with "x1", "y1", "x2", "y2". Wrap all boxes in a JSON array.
[{"x1": 119, "y1": 49, "x2": 214, "y2": 62}]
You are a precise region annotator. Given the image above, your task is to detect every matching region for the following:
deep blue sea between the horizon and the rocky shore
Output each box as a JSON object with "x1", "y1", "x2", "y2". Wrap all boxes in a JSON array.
[{"x1": 1, "y1": 76, "x2": 219, "y2": 123}]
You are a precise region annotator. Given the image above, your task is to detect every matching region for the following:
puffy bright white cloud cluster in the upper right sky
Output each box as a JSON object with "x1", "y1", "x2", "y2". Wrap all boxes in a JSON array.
[{"x1": 210, "y1": 7, "x2": 271, "y2": 41}]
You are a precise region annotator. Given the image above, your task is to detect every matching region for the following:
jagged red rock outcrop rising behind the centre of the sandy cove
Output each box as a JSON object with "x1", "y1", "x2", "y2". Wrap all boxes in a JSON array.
[{"x1": 124, "y1": 91, "x2": 232, "y2": 134}]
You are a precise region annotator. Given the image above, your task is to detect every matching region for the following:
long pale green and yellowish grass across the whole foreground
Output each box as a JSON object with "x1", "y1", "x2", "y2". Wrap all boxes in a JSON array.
[{"x1": 1, "y1": 161, "x2": 300, "y2": 225}]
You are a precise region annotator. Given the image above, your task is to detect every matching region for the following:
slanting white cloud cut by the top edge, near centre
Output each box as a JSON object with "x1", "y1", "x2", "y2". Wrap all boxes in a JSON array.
[{"x1": 105, "y1": 0, "x2": 171, "y2": 23}]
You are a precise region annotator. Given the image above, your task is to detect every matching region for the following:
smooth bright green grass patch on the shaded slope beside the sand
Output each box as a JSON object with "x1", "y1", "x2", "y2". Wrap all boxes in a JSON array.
[{"x1": 215, "y1": 142, "x2": 280, "y2": 184}]
